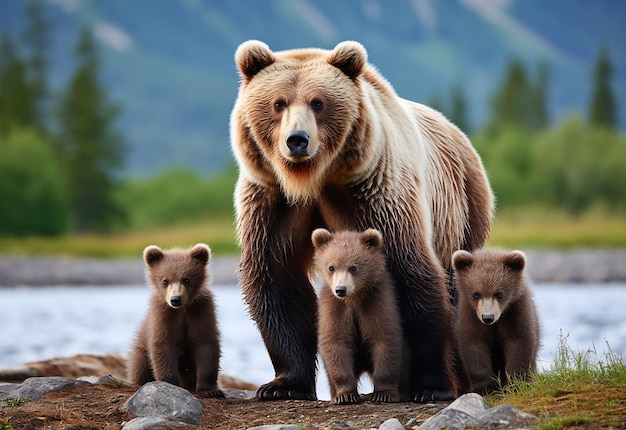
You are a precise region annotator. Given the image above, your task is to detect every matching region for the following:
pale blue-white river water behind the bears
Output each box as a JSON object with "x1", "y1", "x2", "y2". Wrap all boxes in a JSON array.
[{"x1": 0, "y1": 283, "x2": 626, "y2": 399}]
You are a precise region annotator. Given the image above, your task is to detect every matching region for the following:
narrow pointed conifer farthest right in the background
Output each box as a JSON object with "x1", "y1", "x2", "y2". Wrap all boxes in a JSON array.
[{"x1": 589, "y1": 47, "x2": 617, "y2": 129}]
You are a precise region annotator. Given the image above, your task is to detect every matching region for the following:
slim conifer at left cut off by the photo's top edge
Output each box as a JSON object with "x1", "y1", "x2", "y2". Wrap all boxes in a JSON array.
[{"x1": 22, "y1": 0, "x2": 50, "y2": 131}]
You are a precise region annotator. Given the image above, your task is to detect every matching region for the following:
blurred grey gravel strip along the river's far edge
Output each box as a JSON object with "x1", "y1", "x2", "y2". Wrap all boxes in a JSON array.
[{"x1": 0, "y1": 249, "x2": 626, "y2": 287}]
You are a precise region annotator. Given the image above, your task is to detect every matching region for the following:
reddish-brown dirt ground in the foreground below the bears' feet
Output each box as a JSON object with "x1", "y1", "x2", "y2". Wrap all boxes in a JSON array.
[{"x1": 0, "y1": 384, "x2": 447, "y2": 430}]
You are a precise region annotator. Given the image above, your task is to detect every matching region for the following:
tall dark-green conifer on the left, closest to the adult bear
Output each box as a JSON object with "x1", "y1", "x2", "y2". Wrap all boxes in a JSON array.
[{"x1": 56, "y1": 29, "x2": 126, "y2": 231}]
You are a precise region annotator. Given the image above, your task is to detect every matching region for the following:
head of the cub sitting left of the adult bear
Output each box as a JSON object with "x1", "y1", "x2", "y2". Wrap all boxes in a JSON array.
[{"x1": 143, "y1": 243, "x2": 211, "y2": 309}]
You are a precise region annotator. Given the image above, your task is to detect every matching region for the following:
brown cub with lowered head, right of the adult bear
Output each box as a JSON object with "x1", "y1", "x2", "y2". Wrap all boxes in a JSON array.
[{"x1": 452, "y1": 249, "x2": 541, "y2": 394}]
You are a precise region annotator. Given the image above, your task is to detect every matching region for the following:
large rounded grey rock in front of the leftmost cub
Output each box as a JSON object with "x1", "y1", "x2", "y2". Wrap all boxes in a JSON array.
[{"x1": 122, "y1": 381, "x2": 204, "y2": 425}]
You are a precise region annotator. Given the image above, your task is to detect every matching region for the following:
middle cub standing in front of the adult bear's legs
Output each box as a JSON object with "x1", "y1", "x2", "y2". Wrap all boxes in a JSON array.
[{"x1": 311, "y1": 228, "x2": 408, "y2": 404}]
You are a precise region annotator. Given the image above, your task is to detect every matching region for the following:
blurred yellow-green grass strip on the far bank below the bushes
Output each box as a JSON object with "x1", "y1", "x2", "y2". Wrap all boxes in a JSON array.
[{"x1": 0, "y1": 209, "x2": 626, "y2": 258}]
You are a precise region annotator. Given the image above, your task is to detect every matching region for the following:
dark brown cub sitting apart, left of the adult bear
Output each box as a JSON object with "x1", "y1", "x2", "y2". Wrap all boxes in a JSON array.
[{"x1": 128, "y1": 243, "x2": 224, "y2": 397}]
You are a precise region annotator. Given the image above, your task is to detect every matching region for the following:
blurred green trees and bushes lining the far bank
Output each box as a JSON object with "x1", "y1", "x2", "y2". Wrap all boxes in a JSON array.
[{"x1": 0, "y1": 1, "x2": 626, "y2": 236}]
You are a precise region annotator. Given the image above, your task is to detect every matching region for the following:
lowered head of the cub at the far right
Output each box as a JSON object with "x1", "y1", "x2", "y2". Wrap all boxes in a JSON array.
[{"x1": 452, "y1": 249, "x2": 526, "y2": 325}]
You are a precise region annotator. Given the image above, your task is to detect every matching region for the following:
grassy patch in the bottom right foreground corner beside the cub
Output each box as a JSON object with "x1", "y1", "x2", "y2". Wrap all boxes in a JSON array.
[{"x1": 486, "y1": 336, "x2": 626, "y2": 430}]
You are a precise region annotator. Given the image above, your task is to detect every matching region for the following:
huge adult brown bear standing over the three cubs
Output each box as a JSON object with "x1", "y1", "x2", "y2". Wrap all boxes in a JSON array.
[{"x1": 231, "y1": 41, "x2": 493, "y2": 401}]
